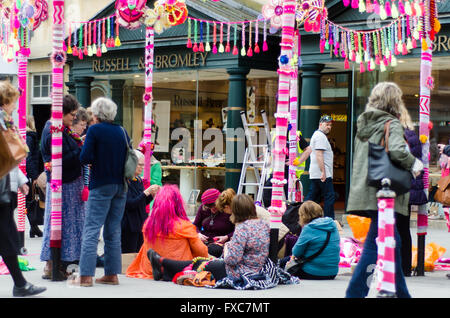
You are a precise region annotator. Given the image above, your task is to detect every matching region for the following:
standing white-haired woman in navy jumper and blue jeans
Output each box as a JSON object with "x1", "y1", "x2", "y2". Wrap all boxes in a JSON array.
[{"x1": 80, "y1": 97, "x2": 130, "y2": 287}]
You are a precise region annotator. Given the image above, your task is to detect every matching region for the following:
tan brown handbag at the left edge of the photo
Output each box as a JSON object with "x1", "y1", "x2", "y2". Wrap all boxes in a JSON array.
[{"x1": 0, "y1": 125, "x2": 28, "y2": 178}]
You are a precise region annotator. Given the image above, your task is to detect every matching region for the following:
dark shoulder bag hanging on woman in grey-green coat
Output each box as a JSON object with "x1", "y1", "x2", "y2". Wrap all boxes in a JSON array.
[{"x1": 367, "y1": 120, "x2": 412, "y2": 195}]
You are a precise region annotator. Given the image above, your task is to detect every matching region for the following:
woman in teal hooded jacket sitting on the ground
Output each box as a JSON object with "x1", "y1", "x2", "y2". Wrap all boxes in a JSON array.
[{"x1": 280, "y1": 201, "x2": 340, "y2": 280}]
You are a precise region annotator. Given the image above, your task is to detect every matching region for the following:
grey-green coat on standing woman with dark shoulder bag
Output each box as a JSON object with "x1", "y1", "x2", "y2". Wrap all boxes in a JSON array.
[{"x1": 347, "y1": 109, "x2": 415, "y2": 215}]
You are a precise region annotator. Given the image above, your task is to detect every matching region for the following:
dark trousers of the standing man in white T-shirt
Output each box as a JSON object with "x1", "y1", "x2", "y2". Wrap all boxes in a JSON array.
[{"x1": 305, "y1": 178, "x2": 336, "y2": 220}]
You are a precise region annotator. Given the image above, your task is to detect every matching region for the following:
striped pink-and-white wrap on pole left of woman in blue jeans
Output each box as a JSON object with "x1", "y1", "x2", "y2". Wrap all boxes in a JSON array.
[{"x1": 50, "y1": 0, "x2": 65, "y2": 248}]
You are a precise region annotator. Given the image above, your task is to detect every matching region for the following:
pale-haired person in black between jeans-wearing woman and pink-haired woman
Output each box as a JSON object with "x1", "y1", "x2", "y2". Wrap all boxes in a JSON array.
[{"x1": 122, "y1": 149, "x2": 159, "y2": 253}]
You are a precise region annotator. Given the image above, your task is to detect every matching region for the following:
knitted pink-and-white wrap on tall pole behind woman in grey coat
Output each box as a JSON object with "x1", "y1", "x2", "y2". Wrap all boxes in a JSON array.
[{"x1": 417, "y1": 46, "x2": 433, "y2": 235}]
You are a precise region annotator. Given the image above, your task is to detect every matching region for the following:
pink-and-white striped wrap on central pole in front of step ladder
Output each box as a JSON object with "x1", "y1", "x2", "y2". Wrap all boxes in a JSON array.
[{"x1": 268, "y1": 0, "x2": 297, "y2": 228}]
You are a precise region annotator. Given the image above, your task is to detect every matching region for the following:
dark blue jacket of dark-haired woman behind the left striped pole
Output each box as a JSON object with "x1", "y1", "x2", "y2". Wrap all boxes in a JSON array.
[{"x1": 41, "y1": 120, "x2": 81, "y2": 183}]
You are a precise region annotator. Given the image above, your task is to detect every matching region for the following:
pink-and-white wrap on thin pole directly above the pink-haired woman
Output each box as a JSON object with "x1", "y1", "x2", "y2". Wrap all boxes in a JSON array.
[{"x1": 143, "y1": 27, "x2": 155, "y2": 182}]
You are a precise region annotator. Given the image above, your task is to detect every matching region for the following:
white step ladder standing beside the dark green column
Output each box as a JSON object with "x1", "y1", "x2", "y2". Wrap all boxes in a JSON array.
[{"x1": 237, "y1": 110, "x2": 272, "y2": 205}]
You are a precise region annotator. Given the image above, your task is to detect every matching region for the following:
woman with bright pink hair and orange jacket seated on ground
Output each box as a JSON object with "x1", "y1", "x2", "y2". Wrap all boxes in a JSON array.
[{"x1": 126, "y1": 185, "x2": 208, "y2": 279}]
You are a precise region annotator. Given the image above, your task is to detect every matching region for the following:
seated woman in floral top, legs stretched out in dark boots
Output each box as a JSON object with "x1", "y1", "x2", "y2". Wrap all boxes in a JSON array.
[{"x1": 147, "y1": 194, "x2": 270, "y2": 281}]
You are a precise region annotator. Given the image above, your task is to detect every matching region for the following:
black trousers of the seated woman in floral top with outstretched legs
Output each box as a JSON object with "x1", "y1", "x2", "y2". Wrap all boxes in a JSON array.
[{"x1": 162, "y1": 258, "x2": 227, "y2": 281}]
